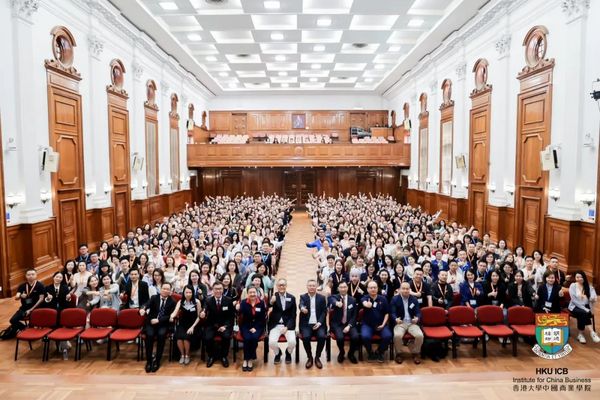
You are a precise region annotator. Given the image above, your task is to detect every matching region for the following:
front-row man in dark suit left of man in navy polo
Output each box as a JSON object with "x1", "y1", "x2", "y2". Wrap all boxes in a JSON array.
[{"x1": 329, "y1": 281, "x2": 358, "y2": 364}]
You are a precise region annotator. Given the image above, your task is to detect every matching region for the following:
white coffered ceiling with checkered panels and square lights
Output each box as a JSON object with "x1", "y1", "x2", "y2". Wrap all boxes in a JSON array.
[{"x1": 111, "y1": 0, "x2": 487, "y2": 94}]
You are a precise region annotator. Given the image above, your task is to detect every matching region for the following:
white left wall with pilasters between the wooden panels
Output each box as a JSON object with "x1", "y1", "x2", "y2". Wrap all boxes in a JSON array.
[{"x1": 0, "y1": 0, "x2": 211, "y2": 225}]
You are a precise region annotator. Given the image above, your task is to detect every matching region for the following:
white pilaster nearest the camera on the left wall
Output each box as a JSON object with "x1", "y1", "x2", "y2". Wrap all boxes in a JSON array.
[{"x1": 8, "y1": 0, "x2": 46, "y2": 225}]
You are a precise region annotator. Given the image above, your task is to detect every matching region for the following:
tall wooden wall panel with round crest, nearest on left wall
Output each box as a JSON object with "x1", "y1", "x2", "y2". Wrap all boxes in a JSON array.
[{"x1": 45, "y1": 35, "x2": 86, "y2": 259}]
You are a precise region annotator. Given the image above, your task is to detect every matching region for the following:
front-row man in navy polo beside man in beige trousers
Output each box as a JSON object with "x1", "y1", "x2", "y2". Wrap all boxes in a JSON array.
[{"x1": 360, "y1": 281, "x2": 392, "y2": 363}]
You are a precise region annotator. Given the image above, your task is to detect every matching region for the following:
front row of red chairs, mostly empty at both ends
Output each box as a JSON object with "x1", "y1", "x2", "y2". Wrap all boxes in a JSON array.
[{"x1": 15, "y1": 305, "x2": 535, "y2": 362}]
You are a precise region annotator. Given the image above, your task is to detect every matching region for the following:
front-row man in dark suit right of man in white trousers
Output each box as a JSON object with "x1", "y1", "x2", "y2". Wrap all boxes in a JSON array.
[{"x1": 299, "y1": 279, "x2": 327, "y2": 369}]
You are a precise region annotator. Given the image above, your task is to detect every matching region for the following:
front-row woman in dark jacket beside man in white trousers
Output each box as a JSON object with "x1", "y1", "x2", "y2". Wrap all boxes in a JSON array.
[{"x1": 240, "y1": 287, "x2": 267, "y2": 372}]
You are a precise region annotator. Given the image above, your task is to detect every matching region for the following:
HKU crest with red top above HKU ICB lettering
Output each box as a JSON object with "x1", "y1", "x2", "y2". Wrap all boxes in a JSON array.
[{"x1": 533, "y1": 314, "x2": 573, "y2": 360}]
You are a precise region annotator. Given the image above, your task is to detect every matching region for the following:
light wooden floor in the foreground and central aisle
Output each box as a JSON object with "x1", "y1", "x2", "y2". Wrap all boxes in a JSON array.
[{"x1": 0, "y1": 212, "x2": 600, "y2": 400}]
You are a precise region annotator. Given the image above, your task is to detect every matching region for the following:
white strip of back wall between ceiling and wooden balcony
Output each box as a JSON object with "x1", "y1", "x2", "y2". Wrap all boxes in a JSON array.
[{"x1": 208, "y1": 93, "x2": 387, "y2": 110}]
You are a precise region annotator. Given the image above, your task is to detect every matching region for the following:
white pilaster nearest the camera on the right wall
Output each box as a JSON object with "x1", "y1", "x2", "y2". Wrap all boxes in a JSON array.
[{"x1": 548, "y1": 0, "x2": 595, "y2": 220}]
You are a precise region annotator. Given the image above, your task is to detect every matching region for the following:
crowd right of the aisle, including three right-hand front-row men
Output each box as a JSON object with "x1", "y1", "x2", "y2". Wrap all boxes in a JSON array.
[{"x1": 307, "y1": 194, "x2": 600, "y2": 364}]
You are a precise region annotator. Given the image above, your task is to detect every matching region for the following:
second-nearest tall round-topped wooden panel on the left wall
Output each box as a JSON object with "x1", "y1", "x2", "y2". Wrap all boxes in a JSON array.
[{"x1": 108, "y1": 63, "x2": 133, "y2": 237}]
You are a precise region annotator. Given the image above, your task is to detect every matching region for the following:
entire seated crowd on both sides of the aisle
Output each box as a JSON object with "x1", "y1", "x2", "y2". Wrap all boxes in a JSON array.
[{"x1": 3, "y1": 194, "x2": 600, "y2": 372}]
